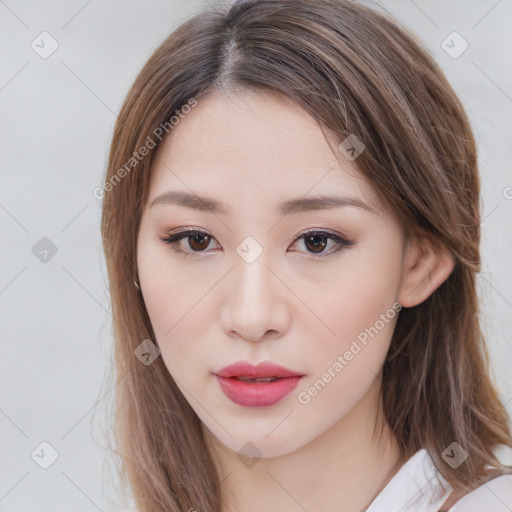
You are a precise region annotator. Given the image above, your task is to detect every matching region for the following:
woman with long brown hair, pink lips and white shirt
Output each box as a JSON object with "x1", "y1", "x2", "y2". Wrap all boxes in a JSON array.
[{"x1": 102, "y1": 0, "x2": 512, "y2": 512}]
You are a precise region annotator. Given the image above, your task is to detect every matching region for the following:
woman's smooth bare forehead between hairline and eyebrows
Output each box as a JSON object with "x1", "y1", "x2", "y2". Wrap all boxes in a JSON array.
[{"x1": 150, "y1": 91, "x2": 376, "y2": 211}]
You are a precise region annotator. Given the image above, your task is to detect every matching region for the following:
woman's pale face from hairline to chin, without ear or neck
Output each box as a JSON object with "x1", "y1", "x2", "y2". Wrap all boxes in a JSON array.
[{"x1": 137, "y1": 93, "x2": 404, "y2": 457}]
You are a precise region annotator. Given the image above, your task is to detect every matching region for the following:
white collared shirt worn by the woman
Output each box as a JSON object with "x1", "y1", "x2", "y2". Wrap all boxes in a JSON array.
[{"x1": 366, "y1": 448, "x2": 512, "y2": 512}]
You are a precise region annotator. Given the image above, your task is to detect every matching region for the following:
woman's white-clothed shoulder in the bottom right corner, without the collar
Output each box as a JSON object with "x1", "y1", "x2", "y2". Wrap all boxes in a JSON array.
[{"x1": 448, "y1": 475, "x2": 512, "y2": 512}]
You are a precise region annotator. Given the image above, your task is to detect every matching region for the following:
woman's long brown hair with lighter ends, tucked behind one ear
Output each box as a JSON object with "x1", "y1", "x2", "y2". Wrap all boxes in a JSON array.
[{"x1": 102, "y1": 0, "x2": 512, "y2": 512}]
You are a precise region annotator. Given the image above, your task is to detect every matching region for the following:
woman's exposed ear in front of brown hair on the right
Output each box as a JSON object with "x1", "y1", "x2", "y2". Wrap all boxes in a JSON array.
[{"x1": 398, "y1": 238, "x2": 455, "y2": 308}]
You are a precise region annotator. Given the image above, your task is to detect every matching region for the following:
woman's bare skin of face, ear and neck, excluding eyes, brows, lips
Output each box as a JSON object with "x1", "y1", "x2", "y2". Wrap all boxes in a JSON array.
[{"x1": 137, "y1": 91, "x2": 453, "y2": 512}]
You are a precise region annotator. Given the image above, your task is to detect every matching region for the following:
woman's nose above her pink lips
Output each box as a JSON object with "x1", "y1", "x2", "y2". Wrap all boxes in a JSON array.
[{"x1": 220, "y1": 253, "x2": 291, "y2": 341}]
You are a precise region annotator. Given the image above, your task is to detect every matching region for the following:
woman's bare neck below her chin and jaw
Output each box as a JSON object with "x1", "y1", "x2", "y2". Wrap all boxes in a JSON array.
[{"x1": 204, "y1": 379, "x2": 399, "y2": 512}]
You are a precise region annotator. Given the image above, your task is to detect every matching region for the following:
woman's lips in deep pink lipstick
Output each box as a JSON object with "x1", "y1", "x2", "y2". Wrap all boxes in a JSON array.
[{"x1": 215, "y1": 361, "x2": 304, "y2": 407}]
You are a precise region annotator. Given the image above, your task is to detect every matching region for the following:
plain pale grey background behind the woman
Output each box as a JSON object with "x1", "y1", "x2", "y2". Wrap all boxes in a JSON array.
[{"x1": 0, "y1": 0, "x2": 512, "y2": 512}]
